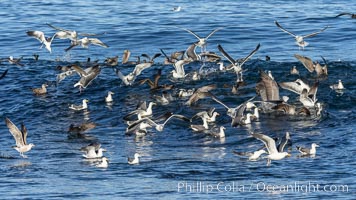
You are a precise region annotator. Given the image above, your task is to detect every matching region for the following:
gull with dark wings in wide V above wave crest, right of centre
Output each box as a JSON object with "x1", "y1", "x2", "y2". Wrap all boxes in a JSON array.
[{"x1": 218, "y1": 44, "x2": 261, "y2": 82}]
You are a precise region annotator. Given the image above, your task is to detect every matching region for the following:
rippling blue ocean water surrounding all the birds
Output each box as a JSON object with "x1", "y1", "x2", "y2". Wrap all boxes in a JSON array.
[{"x1": 0, "y1": 0, "x2": 356, "y2": 199}]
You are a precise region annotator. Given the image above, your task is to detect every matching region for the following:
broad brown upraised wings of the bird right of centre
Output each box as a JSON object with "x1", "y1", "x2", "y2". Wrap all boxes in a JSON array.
[{"x1": 256, "y1": 70, "x2": 280, "y2": 101}]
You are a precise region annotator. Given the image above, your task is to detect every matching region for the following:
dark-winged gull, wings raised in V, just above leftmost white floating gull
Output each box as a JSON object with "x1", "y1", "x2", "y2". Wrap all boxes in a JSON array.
[{"x1": 72, "y1": 65, "x2": 101, "y2": 91}]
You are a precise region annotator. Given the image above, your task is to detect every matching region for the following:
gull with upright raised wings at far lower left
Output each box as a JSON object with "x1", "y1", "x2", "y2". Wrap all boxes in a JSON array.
[{"x1": 5, "y1": 117, "x2": 35, "y2": 158}]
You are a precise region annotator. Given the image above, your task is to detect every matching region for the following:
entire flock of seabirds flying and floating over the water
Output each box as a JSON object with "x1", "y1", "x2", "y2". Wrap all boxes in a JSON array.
[{"x1": 0, "y1": 14, "x2": 354, "y2": 168}]
